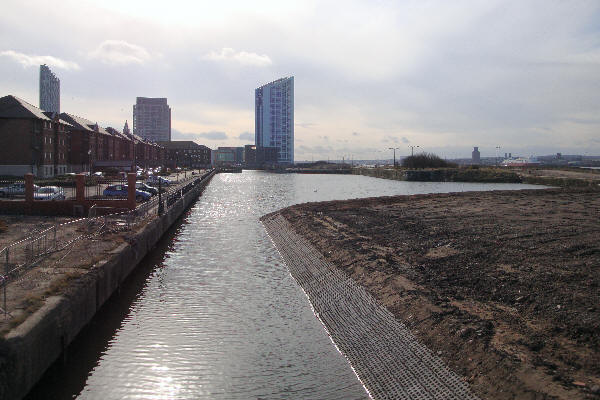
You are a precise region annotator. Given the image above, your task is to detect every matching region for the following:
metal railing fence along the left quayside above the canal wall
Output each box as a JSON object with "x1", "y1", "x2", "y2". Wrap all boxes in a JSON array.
[{"x1": 0, "y1": 167, "x2": 213, "y2": 318}]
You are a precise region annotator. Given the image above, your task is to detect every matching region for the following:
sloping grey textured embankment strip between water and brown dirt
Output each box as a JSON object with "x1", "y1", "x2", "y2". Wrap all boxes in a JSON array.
[{"x1": 262, "y1": 213, "x2": 477, "y2": 400}]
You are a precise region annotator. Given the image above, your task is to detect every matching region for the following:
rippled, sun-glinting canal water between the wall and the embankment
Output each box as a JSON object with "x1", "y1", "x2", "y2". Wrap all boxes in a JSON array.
[{"x1": 24, "y1": 171, "x2": 544, "y2": 399}]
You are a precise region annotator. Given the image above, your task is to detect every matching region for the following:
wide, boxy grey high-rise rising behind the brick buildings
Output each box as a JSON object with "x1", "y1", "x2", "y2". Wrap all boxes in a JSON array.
[{"x1": 133, "y1": 97, "x2": 171, "y2": 142}]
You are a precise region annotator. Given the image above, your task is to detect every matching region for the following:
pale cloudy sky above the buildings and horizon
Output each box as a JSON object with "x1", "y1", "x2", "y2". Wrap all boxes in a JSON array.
[{"x1": 0, "y1": 0, "x2": 600, "y2": 160}]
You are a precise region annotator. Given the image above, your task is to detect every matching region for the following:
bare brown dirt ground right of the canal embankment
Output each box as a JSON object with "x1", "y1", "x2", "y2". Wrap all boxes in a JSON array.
[{"x1": 281, "y1": 189, "x2": 600, "y2": 399}]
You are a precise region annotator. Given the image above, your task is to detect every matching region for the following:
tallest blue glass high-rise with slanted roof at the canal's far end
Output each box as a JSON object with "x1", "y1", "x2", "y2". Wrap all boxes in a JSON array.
[{"x1": 254, "y1": 76, "x2": 294, "y2": 164}]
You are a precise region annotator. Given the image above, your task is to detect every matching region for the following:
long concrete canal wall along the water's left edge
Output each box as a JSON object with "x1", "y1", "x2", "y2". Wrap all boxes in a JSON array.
[{"x1": 0, "y1": 172, "x2": 214, "y2": 399}]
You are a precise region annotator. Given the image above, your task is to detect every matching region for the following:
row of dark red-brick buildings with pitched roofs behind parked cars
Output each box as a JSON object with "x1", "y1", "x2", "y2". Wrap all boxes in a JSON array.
[{"x1": 0, "y1": 95, "x2": 165, "y2": 177}]
